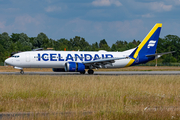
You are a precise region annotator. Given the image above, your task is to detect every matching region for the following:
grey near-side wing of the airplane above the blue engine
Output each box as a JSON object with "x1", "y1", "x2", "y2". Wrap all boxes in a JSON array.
[{"x1": 82, "y1": 57, "x2": 129, "y2": 69}]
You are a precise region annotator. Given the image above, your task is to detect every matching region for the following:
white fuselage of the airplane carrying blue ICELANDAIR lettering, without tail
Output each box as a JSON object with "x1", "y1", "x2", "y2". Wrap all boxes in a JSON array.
[{"x1": 5, "y1": 49, "x2": 134, "y2": 68}]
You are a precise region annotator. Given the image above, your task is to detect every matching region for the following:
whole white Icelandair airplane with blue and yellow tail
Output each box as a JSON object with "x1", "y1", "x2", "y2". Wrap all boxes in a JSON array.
[{"x1": 5, "y1": 23, "x2": 174, "y2": 74}]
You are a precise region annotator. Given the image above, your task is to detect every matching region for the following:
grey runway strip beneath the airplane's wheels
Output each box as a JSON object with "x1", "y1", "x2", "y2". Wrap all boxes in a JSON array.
[{"x1": 0, "y1": 71, "x2": 180, "y2": 76}]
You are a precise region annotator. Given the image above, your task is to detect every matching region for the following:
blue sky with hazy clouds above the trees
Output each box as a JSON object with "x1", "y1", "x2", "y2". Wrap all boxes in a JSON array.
[{"x1": 0, "y1": 0, "x2": 180, "y2": 45}]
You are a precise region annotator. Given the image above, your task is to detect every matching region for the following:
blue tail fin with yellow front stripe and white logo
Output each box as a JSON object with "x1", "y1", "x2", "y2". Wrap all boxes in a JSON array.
[{"x1": 126, "y1": 23, "x2": 162, "y2": 67}]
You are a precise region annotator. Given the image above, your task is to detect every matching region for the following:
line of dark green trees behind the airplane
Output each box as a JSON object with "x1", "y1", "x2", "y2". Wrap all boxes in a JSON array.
[{"x1": 0, "y1": 32, "x2": 180, "y2": 63}]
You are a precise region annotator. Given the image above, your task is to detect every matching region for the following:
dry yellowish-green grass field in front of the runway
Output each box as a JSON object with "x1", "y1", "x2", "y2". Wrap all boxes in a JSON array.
[{"x1": 0, "y1": 75, "x2": 180, "y2": 119}]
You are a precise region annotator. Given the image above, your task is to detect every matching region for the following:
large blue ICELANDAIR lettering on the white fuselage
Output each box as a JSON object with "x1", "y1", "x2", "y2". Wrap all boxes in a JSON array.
[{"x1": 38, "y1": 53, "x2": 113, "y2": 61}]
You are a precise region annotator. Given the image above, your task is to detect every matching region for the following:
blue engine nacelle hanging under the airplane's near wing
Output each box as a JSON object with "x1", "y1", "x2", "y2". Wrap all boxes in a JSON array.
[{"x1": 65, "y1": 62, "x2": 85, "y2": 72}]
